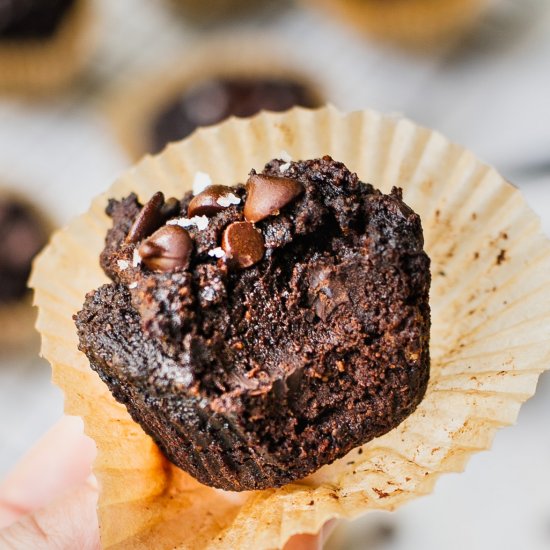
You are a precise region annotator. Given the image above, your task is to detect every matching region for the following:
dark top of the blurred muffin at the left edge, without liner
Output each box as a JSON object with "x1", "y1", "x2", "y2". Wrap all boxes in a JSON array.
[{"x1": 0, "y1": 197, "x2": 48, "y2": 303}]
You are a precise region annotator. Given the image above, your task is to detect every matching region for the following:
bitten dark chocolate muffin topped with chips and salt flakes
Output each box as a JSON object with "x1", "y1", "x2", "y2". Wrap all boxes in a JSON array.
[{"x1": 75, "y1": 157, "x2": 430, "y2": 491}]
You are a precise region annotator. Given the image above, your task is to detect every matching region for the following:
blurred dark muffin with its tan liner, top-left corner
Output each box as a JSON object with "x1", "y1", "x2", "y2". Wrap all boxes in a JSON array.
[{"x1": 0, "y1": 0, "x2": 92, "y2": 93}]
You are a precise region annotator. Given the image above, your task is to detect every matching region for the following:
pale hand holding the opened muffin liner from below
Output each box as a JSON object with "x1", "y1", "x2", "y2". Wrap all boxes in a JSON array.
[{"x1": 0, "y1": 416, "x2": 332, "y2": 550}]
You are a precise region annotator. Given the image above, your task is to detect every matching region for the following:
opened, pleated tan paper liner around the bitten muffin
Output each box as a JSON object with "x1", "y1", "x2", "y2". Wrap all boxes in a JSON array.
[{"x1": 32, "y1": 107, "x2": 550, "y2": 549}]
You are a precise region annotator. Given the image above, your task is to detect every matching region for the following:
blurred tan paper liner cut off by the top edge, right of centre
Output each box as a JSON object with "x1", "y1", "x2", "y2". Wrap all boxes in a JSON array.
[{"x1": 303, "y1": 0, "x2": 492, "y2": 49}]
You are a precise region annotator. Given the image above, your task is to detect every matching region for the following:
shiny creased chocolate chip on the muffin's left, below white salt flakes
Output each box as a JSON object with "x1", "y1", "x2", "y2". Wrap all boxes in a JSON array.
[{"x1": 138, "y1": 225, "x2": 193, "y2": 272}]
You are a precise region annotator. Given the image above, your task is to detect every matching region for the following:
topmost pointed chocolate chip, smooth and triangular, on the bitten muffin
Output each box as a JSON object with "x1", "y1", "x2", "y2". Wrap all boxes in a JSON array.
[{"x1": 244, "y1": 174, "x2": 304, "y2": 223}]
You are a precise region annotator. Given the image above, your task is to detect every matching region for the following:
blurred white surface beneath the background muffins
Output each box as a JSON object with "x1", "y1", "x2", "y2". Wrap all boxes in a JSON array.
[{"x1": 0, "y1": 0, "x2": 550, "y2": 550}]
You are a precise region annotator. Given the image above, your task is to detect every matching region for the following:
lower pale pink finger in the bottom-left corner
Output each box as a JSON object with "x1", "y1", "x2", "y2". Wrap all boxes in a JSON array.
[{"x1": 0, "y1": 483, "x2": 100, "y2": 550}]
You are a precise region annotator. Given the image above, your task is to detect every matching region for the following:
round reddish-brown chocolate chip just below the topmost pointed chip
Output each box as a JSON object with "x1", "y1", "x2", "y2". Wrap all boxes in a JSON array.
[{"x1": 222, "y1": 222, "x2": 265, "y2": 269}]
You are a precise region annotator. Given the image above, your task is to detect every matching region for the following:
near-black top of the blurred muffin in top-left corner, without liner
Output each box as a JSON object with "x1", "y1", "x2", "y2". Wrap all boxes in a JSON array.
[{"x1": 0, "y1": 0, "x2": 76, "y2": 41}]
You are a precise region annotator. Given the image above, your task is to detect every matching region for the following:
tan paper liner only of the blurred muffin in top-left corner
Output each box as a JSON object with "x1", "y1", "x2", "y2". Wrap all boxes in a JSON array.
[{"x1": 0, "y1": 0, "x2": 94, "y2": 96}]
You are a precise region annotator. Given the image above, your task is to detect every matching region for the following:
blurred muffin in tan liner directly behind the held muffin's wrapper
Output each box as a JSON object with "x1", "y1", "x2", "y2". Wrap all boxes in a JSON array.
[{"x1": 107, "y1": 36, "x2": 324, "y2": 159}]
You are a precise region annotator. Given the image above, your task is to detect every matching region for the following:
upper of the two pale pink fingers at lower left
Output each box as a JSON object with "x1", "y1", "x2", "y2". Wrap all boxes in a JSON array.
[{"x1": 0, "y1": 416, "x2": 96, "y2": 528}]
